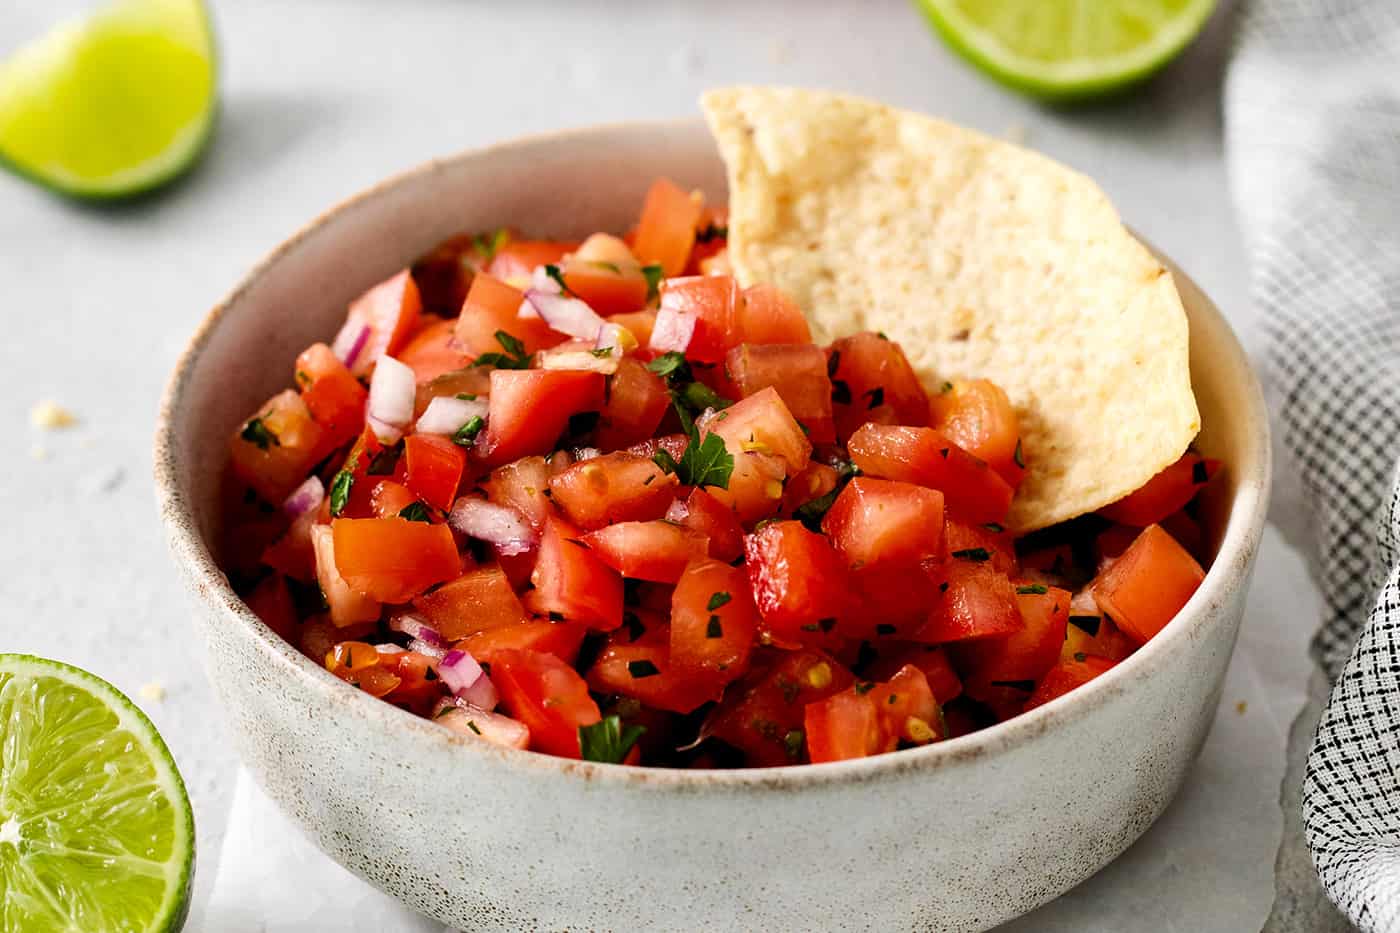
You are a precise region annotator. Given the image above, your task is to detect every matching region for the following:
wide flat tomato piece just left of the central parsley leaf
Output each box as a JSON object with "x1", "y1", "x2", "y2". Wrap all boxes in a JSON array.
[{"x1": 549, "y1": 451, "x2": 676, "y2": 530}]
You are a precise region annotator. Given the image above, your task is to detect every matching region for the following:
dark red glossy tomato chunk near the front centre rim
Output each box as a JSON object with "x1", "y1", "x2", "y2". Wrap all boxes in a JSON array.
[{"x1": 701, "y1": 650, "x2": 855, "y2": 768}]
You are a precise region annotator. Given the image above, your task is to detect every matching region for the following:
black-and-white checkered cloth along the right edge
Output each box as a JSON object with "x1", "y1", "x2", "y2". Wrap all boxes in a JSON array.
[{"x1": 1226, "y1": 0, "x2": 1400, "y2": 930}]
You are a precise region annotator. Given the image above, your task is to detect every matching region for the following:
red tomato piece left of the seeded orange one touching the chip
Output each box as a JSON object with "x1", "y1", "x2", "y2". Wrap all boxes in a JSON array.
[{"x1": 827, "y1": 332, "x2": 928, "y2": 438}]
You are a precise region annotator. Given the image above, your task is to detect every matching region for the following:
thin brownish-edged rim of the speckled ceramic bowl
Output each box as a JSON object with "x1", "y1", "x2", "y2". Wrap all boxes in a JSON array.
[{"x1": 154, "y1": 118, "x2": 1273, "y2": 792}]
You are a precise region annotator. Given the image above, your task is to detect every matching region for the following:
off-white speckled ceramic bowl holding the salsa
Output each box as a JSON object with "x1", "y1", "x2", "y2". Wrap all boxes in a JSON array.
[{"x1": 155, "y1": 122, "x2": 1270, "y2": 930}]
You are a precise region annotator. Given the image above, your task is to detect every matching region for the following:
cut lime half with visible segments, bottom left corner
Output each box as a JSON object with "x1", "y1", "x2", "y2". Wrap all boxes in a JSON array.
[{"x1": 0, "y1": 654, "x2": 195, "y2": 933}]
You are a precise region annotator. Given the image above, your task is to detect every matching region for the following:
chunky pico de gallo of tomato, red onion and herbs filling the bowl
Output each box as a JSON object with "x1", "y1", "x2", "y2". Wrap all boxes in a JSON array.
[{"x1": 223, "y1": 179, "x2": 1219, "y2": 768}]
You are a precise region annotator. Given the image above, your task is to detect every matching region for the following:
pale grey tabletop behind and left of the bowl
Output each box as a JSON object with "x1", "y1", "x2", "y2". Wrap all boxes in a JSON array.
[{"x1": 0, "y1": 0, "x2": 1321, "y2": 918}]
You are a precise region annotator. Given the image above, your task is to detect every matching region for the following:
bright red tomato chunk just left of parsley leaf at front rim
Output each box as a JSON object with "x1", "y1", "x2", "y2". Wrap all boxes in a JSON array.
[{"x1": 491, "y1": 649, "x2": 602, "y2": 758}]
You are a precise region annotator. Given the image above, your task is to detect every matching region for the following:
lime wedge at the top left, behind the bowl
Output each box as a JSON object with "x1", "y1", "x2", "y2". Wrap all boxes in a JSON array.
[{"x1": 0, "y1": 0, "x2": 216, "y2": 198}]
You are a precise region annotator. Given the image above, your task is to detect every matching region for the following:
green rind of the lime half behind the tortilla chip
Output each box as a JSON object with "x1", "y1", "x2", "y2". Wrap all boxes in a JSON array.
[{"x1": 913, "y1": 0, "x2": 1215, "y2": 104}]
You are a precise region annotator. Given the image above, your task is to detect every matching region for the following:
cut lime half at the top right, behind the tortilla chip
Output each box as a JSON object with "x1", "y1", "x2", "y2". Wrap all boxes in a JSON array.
[{"x1": 916, "y1": 0, "x2": 1215, "y2": 101}]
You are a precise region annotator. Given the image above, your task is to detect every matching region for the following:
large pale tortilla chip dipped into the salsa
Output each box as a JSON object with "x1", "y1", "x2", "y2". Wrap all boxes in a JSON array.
[{"x1": 703, "y1": 87, "x2": 1200, "y2": 532}]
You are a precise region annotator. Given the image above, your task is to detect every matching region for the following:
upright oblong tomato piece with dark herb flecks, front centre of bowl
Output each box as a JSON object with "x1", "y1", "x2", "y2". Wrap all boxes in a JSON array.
[{"x1": 671, "y1": 558, "x2": 759, "y2": 684}]
